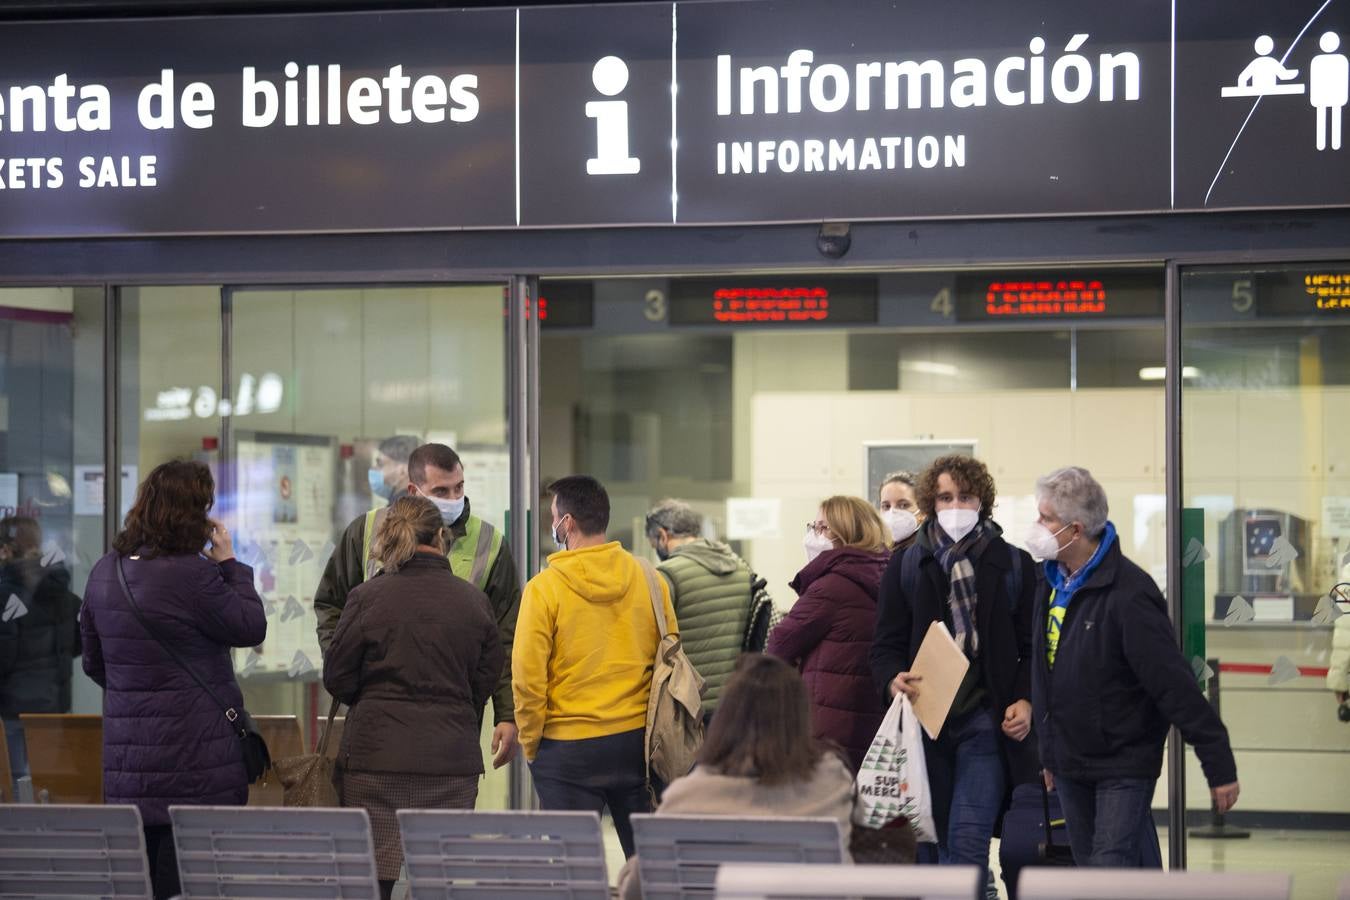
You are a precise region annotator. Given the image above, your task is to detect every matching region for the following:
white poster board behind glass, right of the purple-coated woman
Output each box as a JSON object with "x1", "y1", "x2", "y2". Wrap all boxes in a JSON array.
[{"x1": 234, "y1": 432, "x2": 338, "y2": 680}]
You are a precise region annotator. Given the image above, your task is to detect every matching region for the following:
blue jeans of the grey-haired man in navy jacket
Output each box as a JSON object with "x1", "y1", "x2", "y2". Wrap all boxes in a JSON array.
[{"x1": 1054, "y1": 775, "x2": 1162, "y2": 869}]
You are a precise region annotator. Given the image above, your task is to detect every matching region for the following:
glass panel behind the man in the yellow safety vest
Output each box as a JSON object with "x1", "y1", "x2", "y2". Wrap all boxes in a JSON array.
[{"x1": 220, "y1": 283, "x2": 518, "y2": 808}]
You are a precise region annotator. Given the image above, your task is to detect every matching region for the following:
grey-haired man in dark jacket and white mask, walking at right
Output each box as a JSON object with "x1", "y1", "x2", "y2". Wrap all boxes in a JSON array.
[{"x1": 1026, "y1": 467, "x2": 1238, "y2": 868}]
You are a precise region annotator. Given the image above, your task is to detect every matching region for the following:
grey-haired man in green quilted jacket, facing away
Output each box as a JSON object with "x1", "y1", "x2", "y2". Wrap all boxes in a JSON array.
[{"x1": 647, "y1": 499, "x2": 753, "y2": 721}]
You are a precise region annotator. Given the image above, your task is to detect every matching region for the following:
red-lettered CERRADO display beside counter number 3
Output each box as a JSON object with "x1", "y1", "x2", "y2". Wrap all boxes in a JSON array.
[{"x1": 670, "y1": 278, "x2": 878, "y2": 327}]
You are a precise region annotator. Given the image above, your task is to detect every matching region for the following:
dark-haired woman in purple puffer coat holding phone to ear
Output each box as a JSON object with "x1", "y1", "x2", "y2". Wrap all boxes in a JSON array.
[{"x1": 80, "y1": 461, "x2": 267, "y2": 899}]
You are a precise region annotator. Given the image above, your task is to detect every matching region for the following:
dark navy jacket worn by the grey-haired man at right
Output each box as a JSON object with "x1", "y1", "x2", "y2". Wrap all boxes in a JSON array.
[{"x1": 1033, "y1": 541, "x2": 1238, "y2": 787}]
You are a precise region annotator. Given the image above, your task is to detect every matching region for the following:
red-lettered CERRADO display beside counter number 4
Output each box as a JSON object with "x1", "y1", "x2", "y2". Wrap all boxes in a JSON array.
[{"x1": 956, "y1": 270, "x2": 1164, "y2": 322}]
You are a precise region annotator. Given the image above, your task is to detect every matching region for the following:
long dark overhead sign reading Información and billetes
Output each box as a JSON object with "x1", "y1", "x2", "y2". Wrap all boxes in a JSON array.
[{"x1": 0, "y1": 0, "x2": 1350, "y2": 237}]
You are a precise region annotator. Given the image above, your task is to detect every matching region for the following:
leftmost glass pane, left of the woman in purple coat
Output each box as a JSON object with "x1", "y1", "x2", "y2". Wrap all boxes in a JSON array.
[{"x1": 0, "y1": 287, "x2": 104, "y2": 801}]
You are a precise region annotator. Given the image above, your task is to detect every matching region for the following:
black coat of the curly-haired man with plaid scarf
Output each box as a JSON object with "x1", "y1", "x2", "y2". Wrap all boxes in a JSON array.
[{"x1": 871, "y1": 523, "x2": 1035, "y2": 834}]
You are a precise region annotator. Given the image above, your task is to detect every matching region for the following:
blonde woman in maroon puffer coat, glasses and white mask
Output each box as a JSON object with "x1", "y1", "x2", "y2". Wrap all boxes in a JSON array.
[{"x1": 767, "y1": 497, "x2": 890, "y2": 773}]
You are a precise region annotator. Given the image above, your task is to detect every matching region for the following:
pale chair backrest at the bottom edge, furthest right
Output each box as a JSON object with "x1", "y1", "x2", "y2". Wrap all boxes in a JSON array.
[{"x1": 1018, "y1": 868, "x2": 1293, "y2": 900}]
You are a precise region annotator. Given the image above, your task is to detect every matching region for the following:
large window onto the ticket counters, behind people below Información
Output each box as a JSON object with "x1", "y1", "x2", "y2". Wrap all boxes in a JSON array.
[{"x1": 540, "y1": 270, "x2": 1166, "y2": 607}]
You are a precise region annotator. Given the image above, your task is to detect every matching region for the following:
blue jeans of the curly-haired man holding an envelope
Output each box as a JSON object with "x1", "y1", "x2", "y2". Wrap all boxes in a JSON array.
[{"x1": 930, "y1": 708, "x2": 1004, "y2": 869}]
